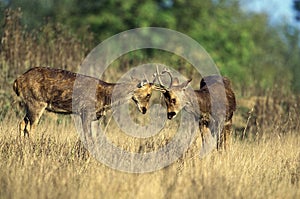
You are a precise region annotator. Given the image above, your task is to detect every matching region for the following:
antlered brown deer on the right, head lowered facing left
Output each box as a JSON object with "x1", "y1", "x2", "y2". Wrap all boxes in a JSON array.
[{"x1": 155, "y1": 69, "x2": 236, "y2": 155}]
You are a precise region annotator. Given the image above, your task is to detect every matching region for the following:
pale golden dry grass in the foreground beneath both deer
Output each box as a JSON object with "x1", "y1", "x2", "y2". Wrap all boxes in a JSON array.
[{"x1": 0, "y1": 110, "x2": 300, "y2": 199}]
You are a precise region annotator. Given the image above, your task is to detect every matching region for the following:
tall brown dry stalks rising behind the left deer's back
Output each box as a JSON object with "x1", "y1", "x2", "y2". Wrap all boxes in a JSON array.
[{"x1": 0, "y1": 9, "x2": 93, "y2": 120}]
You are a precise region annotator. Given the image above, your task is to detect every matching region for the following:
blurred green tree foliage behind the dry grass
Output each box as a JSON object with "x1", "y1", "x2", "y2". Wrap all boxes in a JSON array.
[{"x1": 0, "y1": 0, "x2": 300, "y2": 94}]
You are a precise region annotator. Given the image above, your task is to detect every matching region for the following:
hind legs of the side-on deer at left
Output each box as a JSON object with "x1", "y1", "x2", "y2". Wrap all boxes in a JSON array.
[{"x1": 19, "y1": 102, "x2": 47, "y2": 137}]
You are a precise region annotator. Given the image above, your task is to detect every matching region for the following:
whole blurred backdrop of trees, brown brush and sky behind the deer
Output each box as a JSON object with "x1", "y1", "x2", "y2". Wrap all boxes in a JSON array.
[{"x1": 0, "y1": 0, "x2": 300, "y2": 135}]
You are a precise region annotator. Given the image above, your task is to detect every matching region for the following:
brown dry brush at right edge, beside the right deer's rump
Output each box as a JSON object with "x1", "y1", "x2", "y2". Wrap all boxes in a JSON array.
[{"x1": 234, "y1": 92, "x2": 300, "y2": 140}]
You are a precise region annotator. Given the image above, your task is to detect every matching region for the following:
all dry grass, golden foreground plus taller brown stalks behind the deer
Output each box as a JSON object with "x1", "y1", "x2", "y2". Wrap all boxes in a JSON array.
[{"x1": 0, "y1": 7, "x2": 300, "y2": 198}]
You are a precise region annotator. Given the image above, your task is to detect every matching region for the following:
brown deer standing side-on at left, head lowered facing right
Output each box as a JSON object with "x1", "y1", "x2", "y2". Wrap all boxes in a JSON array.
[{"x1": 13, "y1": 67, "x2": 153, "y2": 136}]
